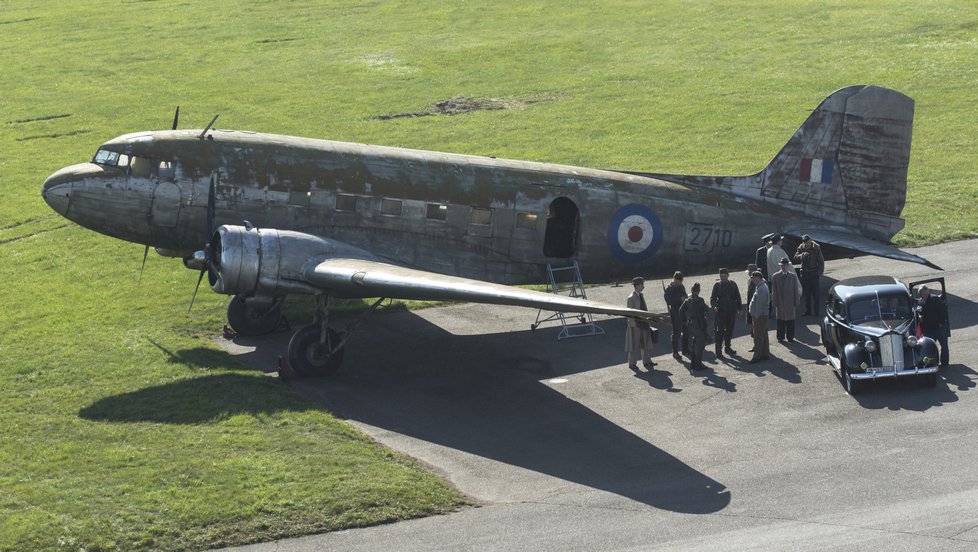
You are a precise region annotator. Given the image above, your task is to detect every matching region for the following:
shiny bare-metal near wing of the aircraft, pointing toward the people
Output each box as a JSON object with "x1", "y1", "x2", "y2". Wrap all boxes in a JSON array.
[{"x1": 303, "y1": 258, "x2": 665, "y2": 323}]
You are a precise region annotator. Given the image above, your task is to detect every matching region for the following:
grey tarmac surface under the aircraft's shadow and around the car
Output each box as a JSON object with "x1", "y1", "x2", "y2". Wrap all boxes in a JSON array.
[{"x1": 217, "y1": 240, "x2": 978, "y2": 552}]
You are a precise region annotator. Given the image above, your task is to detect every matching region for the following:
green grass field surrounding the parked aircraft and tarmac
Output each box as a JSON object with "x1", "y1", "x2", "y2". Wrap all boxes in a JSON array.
[{"x1": 0, "y1": 0, "x2": 978, "y2": 551}]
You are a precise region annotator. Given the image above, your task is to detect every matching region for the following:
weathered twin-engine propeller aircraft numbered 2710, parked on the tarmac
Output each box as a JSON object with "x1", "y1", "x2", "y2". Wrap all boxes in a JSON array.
[{"x1": 42, "y1": 86, "x2": 933, "y2": 375}]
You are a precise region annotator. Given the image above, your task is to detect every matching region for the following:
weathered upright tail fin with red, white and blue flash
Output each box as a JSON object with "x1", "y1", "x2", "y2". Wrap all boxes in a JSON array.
[{"x1": 634, "y1": 85, "x2": 914, "y2": 242}]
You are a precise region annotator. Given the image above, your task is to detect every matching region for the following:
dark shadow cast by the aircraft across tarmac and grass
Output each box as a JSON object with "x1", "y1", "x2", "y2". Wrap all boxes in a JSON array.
[{"x1": 80, "y1": 313, "x2": 730, "y2": 514}]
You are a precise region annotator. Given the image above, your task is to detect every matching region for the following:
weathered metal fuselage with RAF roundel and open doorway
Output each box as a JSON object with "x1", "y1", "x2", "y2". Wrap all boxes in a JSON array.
[{"x1": 43, "y1": 130, "x2": 800, "y2": 284}]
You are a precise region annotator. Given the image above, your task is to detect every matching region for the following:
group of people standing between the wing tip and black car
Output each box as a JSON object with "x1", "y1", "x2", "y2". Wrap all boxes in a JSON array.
[{"x1": 625, "y1": 234, "x2": 825, "y2": 370}]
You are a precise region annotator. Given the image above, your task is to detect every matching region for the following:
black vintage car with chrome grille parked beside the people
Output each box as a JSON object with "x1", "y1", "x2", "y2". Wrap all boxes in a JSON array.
[{"x1": 822, "y1": 276, "x2": 943, "y2": 395}]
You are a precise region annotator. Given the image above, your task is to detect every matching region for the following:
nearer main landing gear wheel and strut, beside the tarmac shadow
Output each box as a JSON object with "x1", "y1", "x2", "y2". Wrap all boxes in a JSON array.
[{"x1": 289, "y1": 295, "x2": 384, "y2": 378}]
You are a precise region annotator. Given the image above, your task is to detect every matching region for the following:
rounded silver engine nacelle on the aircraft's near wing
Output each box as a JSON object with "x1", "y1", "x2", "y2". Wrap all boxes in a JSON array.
[{"x1": 208, "y1": 225, "x2": 374, "y2": 296}]
